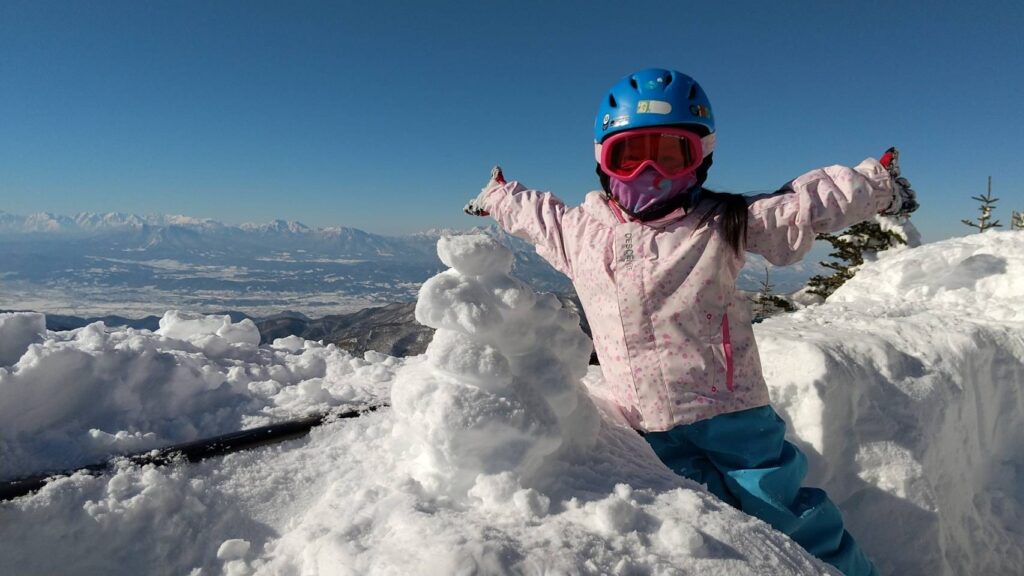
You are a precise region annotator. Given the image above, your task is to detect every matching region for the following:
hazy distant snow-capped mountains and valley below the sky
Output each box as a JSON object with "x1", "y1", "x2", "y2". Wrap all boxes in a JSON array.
[{"x1": 0, "y1": 211, "x2": 817, "y2": 317}]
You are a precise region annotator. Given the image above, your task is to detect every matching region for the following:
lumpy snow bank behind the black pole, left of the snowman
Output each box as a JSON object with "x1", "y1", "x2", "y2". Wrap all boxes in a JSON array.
[{"x1": 0, "y1": 311, "x2": 397, "y2": 481}]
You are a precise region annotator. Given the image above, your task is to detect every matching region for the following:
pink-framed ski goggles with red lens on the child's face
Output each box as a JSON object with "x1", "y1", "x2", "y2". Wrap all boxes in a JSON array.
[{"x1": 594, "y1": 126, "x2": 715, "y2": 181}]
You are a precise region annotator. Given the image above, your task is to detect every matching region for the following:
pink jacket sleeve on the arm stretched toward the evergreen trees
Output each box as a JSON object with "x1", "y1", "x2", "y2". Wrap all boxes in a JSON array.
[{"x1": 746, "y1": 158, "x2": 893, "y2": 265}]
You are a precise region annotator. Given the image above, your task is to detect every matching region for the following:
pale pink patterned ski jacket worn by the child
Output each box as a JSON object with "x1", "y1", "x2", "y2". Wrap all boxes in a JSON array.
[{"x1": 485, "y1": 159, "x2": 893, "y2": 431}]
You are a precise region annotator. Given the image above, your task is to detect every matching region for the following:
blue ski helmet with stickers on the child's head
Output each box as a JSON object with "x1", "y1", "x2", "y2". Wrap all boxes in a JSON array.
[{"x1": 594, "y1": 68, "x2": 715, "y2": 145}]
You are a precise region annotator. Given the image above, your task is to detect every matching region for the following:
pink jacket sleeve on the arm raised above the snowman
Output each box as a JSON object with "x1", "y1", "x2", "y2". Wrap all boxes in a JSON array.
[{"x1": 486, "y1": 180, "x2": 572, "y2": 278}]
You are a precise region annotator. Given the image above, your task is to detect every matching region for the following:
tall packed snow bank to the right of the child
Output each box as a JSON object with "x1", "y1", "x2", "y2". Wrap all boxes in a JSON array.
[{"x1": 755, "y1": 232, "x2": 1024, "y2": 576}]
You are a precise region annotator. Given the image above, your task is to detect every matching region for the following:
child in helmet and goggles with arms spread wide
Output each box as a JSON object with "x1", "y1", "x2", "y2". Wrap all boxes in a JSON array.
[{"x1": 466, "y1": 69, "x2": 916, "y2": 576}]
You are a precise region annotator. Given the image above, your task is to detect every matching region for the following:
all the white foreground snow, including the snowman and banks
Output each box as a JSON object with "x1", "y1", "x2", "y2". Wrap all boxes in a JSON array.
[{"x1": 0, "y1": 232, "x2": 1024, "y2": 575}]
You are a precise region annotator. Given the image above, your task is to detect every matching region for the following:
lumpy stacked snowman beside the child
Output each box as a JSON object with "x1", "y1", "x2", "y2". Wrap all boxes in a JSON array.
[{"x1": 391, "y1": 235, "x2": 598, "y2": 497}]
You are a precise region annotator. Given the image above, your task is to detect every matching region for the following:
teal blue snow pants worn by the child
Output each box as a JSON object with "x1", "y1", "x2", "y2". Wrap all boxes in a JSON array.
[{"x1": 644, "y1": 406, "x2": 878, "y2": 576}]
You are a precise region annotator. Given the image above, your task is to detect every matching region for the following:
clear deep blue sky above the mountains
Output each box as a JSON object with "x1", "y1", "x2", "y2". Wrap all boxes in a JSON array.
[{"x1": 0, "y1": 0, "x2": 1024, "y2": 241}]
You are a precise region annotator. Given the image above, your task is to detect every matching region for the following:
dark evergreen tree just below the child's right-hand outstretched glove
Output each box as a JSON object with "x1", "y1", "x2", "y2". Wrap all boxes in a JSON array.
[{"x1": 807, "y1": 220, "x2": 906, "y2": 298}]
